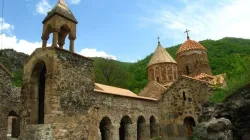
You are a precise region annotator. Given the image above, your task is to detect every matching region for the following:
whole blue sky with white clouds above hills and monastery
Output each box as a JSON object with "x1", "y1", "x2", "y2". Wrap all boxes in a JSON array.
[{"x1": 0, "y1": 0, "x2": 250, "y2": 62}]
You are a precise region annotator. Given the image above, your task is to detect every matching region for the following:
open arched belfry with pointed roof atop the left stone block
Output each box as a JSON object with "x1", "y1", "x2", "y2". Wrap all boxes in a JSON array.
[{"x1": 41, "y1": 0, "x2": 77, "y2": 52}]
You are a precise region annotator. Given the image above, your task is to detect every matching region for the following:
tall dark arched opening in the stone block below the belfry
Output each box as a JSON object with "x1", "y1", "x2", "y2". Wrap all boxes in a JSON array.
[{"x1": 31, "y1": 61, "x2": 47, "y2": 124}]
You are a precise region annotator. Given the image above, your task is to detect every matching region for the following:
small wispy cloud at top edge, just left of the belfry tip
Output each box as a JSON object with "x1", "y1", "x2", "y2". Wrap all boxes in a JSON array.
[{"x1": 36, "y1": 0, "x2": 52, "y2": 15}]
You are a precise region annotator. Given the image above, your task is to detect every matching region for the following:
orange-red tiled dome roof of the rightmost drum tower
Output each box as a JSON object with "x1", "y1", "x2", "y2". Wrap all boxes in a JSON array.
[{"x1": 176, "y1": 37, "x2": 207, "y2": 54}]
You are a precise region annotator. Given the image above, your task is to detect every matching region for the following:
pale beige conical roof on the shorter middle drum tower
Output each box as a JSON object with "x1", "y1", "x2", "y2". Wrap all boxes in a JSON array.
[{"x1": 147, "y1": 42, "x2": 176, "y2": 67}]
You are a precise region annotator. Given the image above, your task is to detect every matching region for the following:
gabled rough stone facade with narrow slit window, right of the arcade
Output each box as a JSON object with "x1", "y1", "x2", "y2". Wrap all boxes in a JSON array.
[{"x1": 159, "y1": 78, "x2": 211, "y2": 138}]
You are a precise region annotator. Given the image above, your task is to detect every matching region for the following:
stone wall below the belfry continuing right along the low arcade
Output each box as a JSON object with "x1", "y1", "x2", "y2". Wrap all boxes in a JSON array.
[{"x1": 21, "y1": 48, "x2": 159, "y2": 140}]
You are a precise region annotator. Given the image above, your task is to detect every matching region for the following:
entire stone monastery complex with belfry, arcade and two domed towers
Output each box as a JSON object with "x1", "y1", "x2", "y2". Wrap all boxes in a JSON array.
[{"x1": 0, "y1": 0, "x2": 225, "y2": 140}]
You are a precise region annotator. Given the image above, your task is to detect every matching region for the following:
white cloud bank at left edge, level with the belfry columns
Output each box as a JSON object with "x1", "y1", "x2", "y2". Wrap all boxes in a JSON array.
[{"x1": 0, "y1": 34, "x2": 42, "y2": 54}]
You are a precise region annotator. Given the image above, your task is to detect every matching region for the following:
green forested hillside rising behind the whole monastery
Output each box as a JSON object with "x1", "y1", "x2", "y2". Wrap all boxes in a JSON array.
[{"x1": 0, "y1": 38, "x2": 250, "y2": 93}]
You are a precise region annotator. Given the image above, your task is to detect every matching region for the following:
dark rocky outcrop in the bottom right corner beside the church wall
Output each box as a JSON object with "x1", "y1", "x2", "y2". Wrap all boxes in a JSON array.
[{"x1": 193, "y1": 85, "x2": 250, "y2": 140}]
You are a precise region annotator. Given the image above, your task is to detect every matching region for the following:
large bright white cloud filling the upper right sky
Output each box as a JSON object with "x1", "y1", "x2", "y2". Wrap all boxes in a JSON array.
[{"x1": 141, "y1": 0, "x2": 250, "y2": 43}]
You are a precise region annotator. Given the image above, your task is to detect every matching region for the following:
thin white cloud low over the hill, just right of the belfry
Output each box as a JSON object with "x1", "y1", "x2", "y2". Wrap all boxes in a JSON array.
[{"x1": 79, "y1": 48, "x2": 116, "y2": 60}]
